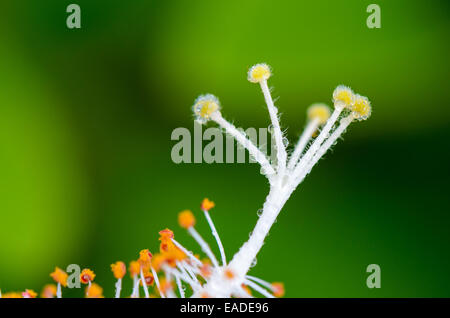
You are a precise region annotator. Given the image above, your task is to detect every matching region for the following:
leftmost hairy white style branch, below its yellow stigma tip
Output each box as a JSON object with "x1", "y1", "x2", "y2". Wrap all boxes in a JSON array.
[{"x1": 211, "y1": 111, "x2": 275, "y2": 177}]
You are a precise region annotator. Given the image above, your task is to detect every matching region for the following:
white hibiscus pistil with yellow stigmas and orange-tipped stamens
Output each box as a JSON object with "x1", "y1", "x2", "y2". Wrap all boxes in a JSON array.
[{"x1": 3, "y1": 64, "x2": 372, "y2": 298}]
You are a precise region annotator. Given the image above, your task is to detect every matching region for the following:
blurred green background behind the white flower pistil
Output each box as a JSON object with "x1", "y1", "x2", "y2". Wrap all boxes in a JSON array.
[{"x1": 0, "y1": 0, "x2": 450, "y2": 297}]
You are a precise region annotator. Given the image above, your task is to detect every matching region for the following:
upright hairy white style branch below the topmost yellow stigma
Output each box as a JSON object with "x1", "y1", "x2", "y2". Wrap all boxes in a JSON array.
[{"x1": 259, "y1": 80, "x2": 287, "y2": 182}]
